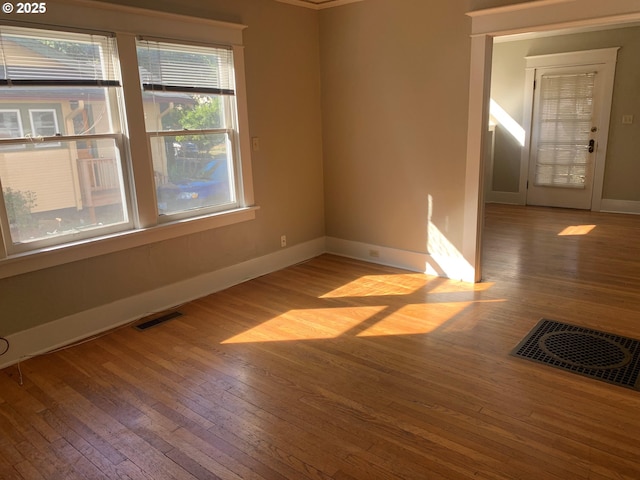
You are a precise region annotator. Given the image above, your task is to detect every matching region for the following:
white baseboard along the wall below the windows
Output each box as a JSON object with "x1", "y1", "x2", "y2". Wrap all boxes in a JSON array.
[{"x1": 0, "y1": 237, "x2": 326, "y2": 368}]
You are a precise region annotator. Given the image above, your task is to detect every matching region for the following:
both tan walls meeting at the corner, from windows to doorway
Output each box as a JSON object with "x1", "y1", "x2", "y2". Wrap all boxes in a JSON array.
[{"x1": 0, "y1": 0, "x2": 540, "y2": 335}]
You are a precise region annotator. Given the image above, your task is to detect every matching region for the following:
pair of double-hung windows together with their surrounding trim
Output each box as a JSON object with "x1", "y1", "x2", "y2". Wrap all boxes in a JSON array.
[{"x1": 0, "y1": 10, "x2": 257, "y2": 278}]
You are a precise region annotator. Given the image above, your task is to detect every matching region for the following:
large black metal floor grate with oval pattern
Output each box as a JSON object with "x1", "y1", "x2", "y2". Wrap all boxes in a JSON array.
[{"x1": 511, "y1": 318, "x2": 640, "y2": 390}]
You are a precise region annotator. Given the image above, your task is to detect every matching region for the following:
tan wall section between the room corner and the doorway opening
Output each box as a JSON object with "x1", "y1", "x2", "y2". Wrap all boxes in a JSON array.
[{"x1": 320, "y1": 0, "x2": 470, "y2": 253}]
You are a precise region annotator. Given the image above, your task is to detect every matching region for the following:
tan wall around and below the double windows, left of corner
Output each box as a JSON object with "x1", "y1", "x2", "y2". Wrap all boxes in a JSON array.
[{"x1": 0, "y1": 0, "x2": 324, "y2": 336}]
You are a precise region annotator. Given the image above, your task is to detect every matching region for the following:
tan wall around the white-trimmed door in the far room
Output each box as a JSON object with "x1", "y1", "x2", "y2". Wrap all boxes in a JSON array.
[{"x1": 492, "y1": 27, "x2": 640, "y2": 201}]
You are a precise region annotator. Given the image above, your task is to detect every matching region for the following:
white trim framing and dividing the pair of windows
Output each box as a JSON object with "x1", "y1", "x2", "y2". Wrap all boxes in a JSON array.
[{"x1": 0, "y1": 0, "x2": 258, "y2": 278}]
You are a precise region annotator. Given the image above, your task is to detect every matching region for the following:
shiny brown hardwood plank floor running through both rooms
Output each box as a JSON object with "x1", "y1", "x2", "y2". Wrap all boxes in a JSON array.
[{"x1": 0, "y1": 205, "x2": 640, "y2": 480}]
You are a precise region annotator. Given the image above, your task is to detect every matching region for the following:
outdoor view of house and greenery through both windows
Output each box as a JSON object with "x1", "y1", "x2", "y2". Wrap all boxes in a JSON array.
[{"x1": 0, "y1": 34, "x2": 232, "y2": 242}]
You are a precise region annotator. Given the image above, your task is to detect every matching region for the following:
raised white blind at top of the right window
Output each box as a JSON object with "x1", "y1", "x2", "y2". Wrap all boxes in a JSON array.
[{"x1": 137, "y1": 39, "x2": 235, "y2": 95}]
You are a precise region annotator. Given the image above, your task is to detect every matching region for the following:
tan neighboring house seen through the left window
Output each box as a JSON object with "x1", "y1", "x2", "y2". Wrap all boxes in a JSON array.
[{"x1": 0, "y1": 32, "x2": 124, "y2": 235}]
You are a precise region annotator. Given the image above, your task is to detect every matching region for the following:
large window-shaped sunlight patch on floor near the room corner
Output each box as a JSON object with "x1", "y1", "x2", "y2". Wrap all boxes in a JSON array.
[{"x1": 222, "y1": 273, "x2": 504, "y2": 344}]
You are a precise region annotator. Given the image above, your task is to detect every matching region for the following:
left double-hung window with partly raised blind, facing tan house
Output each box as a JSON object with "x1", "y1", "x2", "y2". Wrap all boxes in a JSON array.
[{"x1": 0, "y1": 26, "x2": 131, "y2": 253}]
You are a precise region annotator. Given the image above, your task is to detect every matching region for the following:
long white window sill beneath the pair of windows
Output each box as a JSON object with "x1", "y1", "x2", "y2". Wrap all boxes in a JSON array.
[{"x1": 0, "y1": 206, "x2": 259, "y2": 278}]
